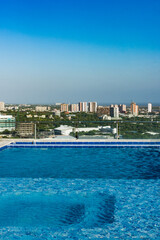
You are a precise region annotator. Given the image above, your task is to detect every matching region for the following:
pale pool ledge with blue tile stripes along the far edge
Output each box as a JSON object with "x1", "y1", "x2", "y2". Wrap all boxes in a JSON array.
[{"x1": 0, "y1": 138, "x2": 160, "y2": 150}]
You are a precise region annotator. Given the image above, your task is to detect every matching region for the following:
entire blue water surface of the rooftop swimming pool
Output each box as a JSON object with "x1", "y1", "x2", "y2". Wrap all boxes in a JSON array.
[{"x1": 0, "y1": 148, "x2": 160, "y2": 240}]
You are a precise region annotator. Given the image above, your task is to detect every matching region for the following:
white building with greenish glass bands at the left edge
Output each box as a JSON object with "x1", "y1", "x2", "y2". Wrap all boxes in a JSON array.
[{"x1": 0, "y1": 115, "x2": 15, "y2": 132}]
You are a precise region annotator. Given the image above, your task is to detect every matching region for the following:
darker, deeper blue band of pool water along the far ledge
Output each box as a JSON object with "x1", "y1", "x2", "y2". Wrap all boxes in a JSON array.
[{"x1": 0, "y1": 148, "x2": 160, "y2": 179}]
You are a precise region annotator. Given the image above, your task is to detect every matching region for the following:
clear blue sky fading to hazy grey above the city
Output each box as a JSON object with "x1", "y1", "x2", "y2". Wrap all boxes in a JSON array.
[{"x1": 0, "y1": 0, "x2": 160, "y2": 104}]
